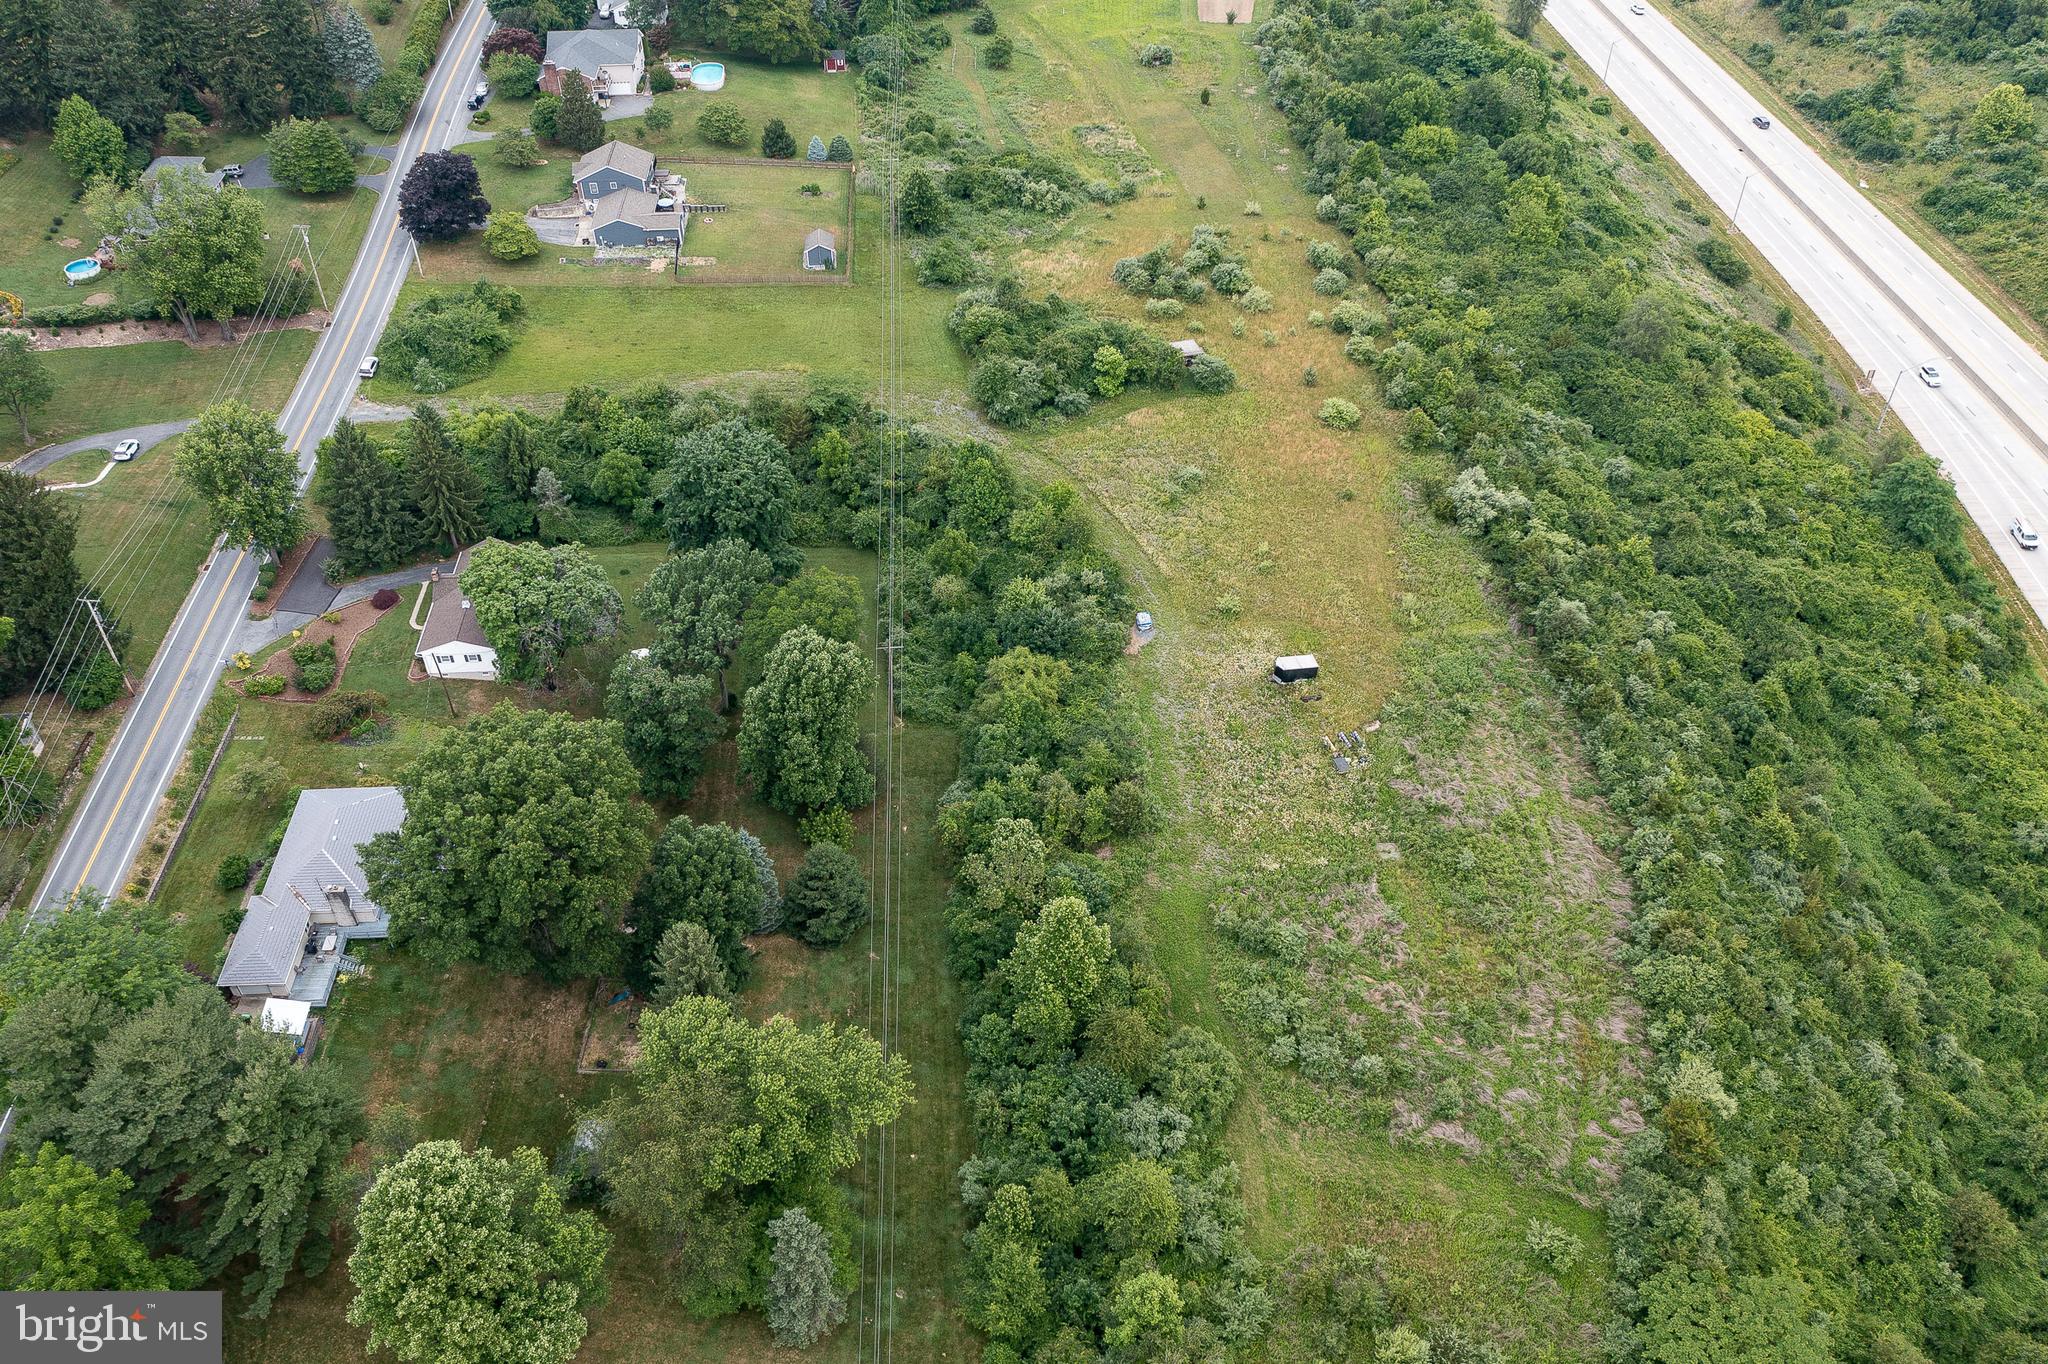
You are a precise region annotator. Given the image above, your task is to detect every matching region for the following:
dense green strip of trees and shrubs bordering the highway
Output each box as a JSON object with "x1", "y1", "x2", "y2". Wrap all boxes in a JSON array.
[{"x1": 1255, "y1": 0, "x2": 2048, "y2": 1364}]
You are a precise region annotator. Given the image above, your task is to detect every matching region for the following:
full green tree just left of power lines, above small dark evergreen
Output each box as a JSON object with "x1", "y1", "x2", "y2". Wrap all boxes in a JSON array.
[{"x1": 739, "y1": 627, "x2": 874, "y2": 813}]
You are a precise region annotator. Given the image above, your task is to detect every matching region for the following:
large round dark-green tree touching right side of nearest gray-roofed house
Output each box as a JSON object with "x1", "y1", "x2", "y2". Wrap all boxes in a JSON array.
[{"x1": 362, "y1": 705, "x2": 647, "y2": 979}]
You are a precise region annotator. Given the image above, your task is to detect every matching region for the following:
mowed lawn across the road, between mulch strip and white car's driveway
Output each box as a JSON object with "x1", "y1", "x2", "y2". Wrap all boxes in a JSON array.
[{"x1": 0, "y1": 330, "x2": 315, "y2": 459}]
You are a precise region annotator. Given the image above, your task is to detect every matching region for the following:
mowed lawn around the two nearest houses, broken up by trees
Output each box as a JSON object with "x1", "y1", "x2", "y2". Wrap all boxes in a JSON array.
[{"x1": 148, "y1": 545, "x2": 969, "y2": 1364}]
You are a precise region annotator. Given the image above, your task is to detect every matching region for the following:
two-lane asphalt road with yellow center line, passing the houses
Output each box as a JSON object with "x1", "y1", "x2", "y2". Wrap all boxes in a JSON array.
[{"x1": 35, "y1": 0, "x2": 492, "y2": 913}]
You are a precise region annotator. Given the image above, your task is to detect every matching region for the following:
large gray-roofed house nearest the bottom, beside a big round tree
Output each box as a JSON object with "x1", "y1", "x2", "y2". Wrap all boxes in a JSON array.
[{"x1": 217, "y1": 786, "x2": 406, "y2": 1008}]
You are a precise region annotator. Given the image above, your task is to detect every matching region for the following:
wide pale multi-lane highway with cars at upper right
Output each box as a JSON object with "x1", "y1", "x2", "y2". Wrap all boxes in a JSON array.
[{"x1": 1548, "y1": 0, "x2": 2048, "y2": 621}]
